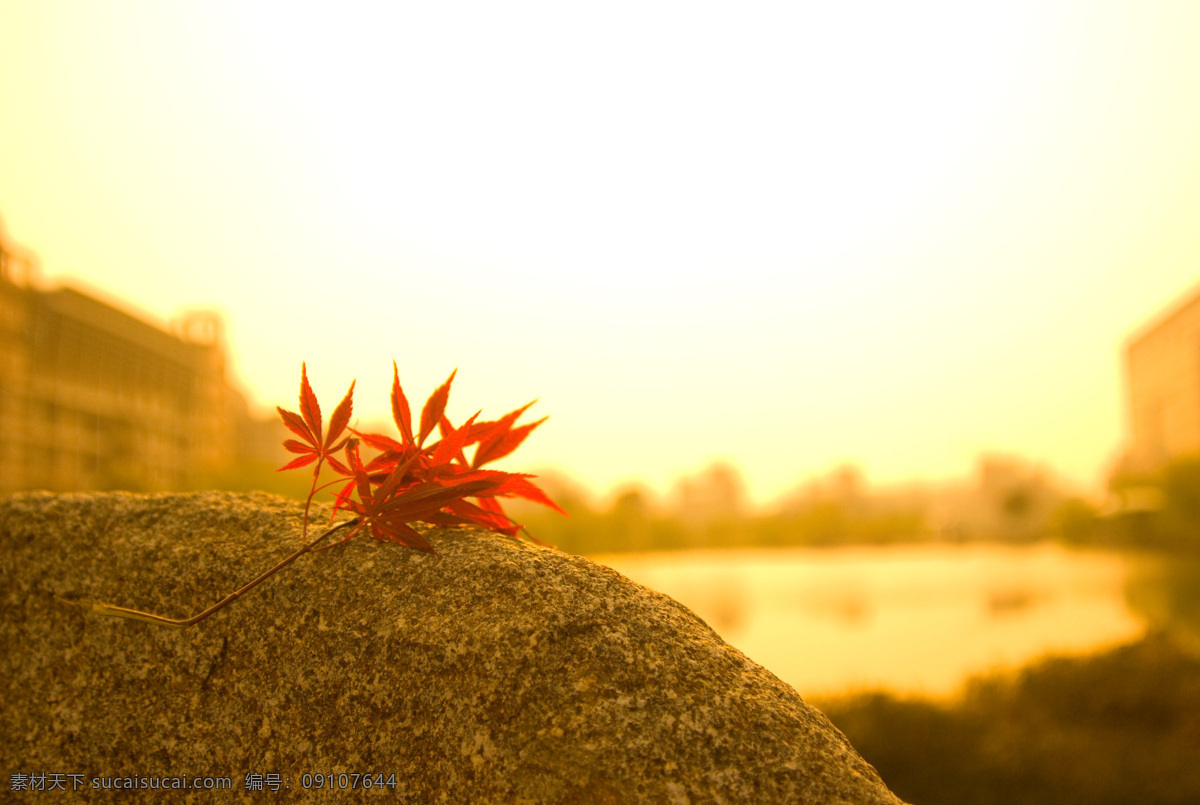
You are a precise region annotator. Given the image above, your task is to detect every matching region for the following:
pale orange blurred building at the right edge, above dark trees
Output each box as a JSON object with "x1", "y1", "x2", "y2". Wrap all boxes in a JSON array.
[{"x1": 1121, "y1": 281, "x2": 1200, "y2": 475}]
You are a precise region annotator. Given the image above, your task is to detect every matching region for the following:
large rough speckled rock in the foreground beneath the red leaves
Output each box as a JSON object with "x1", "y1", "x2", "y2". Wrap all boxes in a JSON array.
[{"x1": 0, "y1": 492, "x2": 900, "y2": 803}]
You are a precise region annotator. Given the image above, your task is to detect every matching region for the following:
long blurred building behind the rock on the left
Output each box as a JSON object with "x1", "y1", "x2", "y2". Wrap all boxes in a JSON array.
[{"x1": 0, "y1": 226, "x2": 254, "y2": 493}]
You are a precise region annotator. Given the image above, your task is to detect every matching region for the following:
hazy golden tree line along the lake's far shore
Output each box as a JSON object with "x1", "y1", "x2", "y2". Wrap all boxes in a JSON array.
[{"x1": 511, "y1": 457, "x2": 1093, "y2": 554}]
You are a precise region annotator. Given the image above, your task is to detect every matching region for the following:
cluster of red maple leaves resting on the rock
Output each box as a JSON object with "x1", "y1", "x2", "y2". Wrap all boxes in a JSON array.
[{"x1": 276, "y1": 361, "x2": 566, "y2": 553}]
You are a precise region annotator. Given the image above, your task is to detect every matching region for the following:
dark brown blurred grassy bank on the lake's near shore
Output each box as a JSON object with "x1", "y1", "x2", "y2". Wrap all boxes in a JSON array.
[{"x1": 812, "y1": 633, "x2": 1200, "y2": 805}]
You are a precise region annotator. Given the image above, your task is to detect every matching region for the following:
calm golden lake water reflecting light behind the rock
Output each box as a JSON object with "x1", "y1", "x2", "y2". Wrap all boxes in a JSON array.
[{"x1": 598, "y1": 543, "x2": 1161, "y2": 697}]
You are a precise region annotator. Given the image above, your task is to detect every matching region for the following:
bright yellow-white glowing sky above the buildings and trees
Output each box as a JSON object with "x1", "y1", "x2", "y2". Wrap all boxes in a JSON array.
[{"x1": 0, "y1": 0, "x2": 1200, "y2": 500}]
